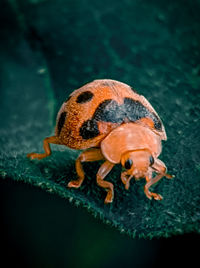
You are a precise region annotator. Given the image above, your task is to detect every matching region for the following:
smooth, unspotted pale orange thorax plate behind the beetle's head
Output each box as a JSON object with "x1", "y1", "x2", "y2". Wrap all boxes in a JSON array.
[{"x1": 101, "y1": 123, "x2": 161, "y2": 163}]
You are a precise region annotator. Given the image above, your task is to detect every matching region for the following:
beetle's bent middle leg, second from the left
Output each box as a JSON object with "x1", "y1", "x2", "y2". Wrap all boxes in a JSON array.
[{"x1": 67, "y1": 148, "x2": 104, "y2": 188}]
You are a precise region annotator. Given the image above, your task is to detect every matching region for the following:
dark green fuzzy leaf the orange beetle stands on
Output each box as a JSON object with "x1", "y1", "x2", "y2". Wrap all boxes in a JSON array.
[{"x1": 0, "y1": 0, "x2": 200, "y2": 238}]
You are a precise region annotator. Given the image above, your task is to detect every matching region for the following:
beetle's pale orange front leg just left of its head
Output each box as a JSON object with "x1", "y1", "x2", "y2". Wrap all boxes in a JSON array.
[{"x1": 97, "y1": 161, "x2": 115, "y2": 204}]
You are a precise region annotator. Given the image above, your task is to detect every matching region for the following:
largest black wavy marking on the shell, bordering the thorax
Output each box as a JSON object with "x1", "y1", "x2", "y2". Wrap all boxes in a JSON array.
[{"x1": 80, "y1": 98, "x2": 162, "y2": 139}]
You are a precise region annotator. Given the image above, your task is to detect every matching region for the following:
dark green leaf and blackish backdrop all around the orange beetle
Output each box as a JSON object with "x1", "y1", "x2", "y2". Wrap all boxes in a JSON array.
[{"x1": 0, "y1": 0, "x2": 200, "y2": 267}]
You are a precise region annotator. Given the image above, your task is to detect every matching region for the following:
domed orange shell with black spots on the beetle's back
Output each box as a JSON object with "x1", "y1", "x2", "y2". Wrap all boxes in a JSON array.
[{"x1": 55, "y1": 79, "x2": 167, "y2": 149}]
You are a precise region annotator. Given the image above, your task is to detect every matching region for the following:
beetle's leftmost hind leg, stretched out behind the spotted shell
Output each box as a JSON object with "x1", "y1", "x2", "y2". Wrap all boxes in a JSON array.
[{"x1": 27, "y1": 136, "x2": 60, "y2": 159}]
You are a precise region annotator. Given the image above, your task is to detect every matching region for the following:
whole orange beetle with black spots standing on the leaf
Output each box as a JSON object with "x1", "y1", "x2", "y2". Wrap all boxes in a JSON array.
[{"x1": 27, "y1": 79, "x2": 173, "y2": 203}]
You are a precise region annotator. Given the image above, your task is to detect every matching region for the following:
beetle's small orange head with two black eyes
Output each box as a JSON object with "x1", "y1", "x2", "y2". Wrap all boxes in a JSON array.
[{"x1": 121, "y1": 149, "x2": 154, "y2": 179}]
